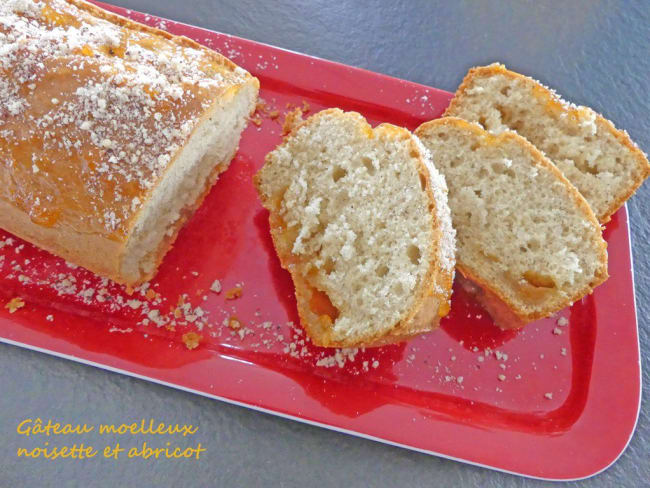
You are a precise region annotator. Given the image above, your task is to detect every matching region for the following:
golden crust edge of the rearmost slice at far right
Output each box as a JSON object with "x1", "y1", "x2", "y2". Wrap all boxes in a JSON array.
[{"x1": 442, "y1": 63, "x2": 650, "y2": 223}]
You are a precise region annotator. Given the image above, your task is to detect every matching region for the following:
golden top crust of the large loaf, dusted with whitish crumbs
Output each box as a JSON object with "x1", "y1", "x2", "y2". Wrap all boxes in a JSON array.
[{"x1": 0, "y1": 0, "x2": 249, "y2": 237}]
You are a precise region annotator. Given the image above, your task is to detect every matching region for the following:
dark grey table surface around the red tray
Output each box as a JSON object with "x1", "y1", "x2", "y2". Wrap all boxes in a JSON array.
[{"x1": 0, "y1": 0, "x2": 650, "y2": 488}]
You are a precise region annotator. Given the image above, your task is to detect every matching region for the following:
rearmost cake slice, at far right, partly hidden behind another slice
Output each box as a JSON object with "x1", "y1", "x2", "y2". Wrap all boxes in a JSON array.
[{"x1": 444, "y1": 64, "x2": 650, "y2": 222}]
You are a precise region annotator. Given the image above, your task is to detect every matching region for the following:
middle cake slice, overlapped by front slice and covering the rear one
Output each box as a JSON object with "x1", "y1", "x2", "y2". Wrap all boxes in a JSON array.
[{"x1": 415, "y1": 117, "x2": 607, "y2": 328}]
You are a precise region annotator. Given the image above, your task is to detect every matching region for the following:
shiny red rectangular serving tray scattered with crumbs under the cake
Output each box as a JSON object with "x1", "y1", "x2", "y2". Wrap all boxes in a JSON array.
[{"x1": 0, "y1": 0, "x2": 640, "y2": 480}]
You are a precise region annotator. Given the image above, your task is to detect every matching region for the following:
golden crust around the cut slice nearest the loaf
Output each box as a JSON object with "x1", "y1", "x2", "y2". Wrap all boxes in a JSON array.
[{"x1": 253, "y1": 109, "x2": 452, "y2": 347}]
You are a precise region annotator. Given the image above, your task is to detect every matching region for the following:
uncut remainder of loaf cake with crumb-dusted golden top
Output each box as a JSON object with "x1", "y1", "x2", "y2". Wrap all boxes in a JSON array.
[{"x1": 0, "y1": 0, "x2": 259, "y2": 285}]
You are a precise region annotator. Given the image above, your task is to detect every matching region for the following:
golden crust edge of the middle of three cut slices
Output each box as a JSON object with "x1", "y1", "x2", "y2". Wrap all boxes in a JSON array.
[{"x1": 415, "y1": 117, "x2": 609, "y2": 328}]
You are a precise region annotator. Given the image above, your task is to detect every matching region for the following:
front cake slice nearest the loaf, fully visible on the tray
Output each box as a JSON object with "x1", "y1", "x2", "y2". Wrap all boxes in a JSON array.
[{"x1": 255, "y1": 109, "x2": 454, "y2": 347}]
